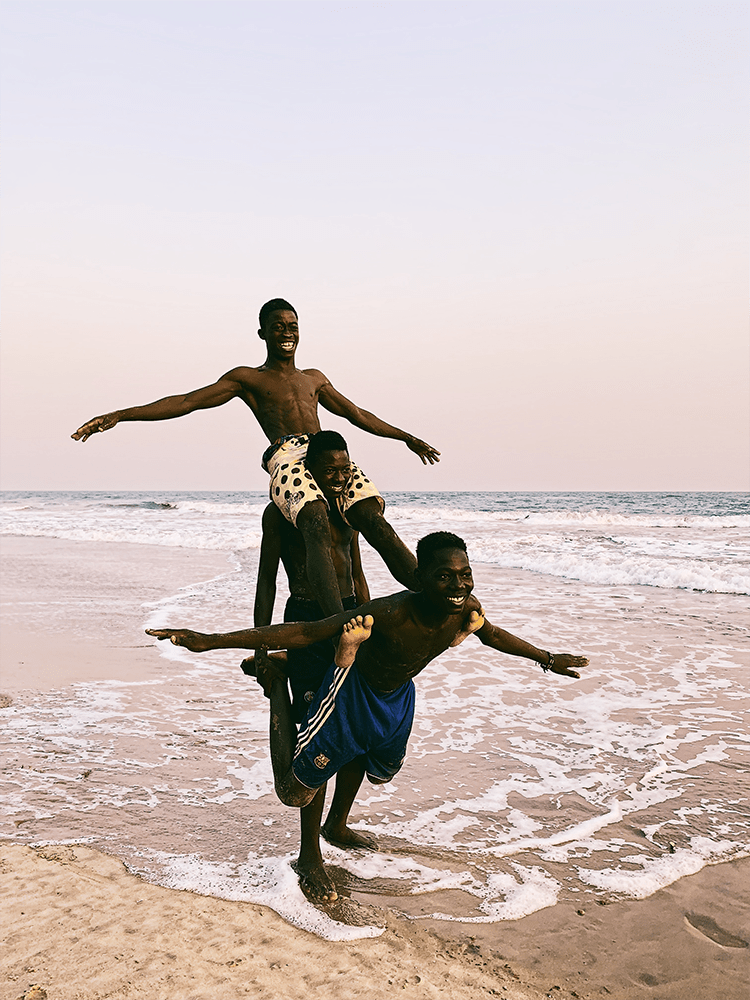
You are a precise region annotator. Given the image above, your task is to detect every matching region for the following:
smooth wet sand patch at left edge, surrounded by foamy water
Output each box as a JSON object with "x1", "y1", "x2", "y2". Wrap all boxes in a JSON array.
[{"x1": 0, "y1": 535, "x2": 233, "y2": 694}]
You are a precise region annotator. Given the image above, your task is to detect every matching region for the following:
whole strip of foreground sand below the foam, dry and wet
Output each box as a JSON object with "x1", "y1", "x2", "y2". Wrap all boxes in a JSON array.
[{"x1": 0, "y1": 841, "x2": 750, "y2": 1000}]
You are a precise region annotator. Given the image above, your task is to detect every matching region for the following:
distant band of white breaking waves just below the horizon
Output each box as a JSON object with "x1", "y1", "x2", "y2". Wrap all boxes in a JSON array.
[{"x1": 5, "y1": 493, "x2": 750, "y2": 594}]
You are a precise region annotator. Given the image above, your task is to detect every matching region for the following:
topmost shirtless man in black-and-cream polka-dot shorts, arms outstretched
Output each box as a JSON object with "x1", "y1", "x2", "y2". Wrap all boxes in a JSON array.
[{"x1": 71, "y1": 299, "x2": 440, "y2": 615}]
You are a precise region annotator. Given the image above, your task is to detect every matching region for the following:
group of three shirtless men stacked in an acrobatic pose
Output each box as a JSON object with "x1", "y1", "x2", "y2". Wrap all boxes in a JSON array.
[{"x1": 78, "y1": 299, "x2": 588, "y2": 902}]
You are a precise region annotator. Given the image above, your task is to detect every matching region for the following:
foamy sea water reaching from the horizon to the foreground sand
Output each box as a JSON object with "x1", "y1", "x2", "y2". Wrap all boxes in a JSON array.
[{"x1": 0, "y1": 491, "x2": 750, "y2": 940}]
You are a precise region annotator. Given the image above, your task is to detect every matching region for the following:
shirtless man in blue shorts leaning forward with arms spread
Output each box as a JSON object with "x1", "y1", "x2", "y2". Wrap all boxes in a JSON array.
[{"x1": 147, "y1": 531, "x2": 588, "y2": 900}]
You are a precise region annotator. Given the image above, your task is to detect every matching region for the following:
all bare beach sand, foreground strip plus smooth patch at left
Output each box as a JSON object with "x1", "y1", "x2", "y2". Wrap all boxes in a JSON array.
[{"x1": 0, "y1": 538, "x2": 750, "y2": 1000}]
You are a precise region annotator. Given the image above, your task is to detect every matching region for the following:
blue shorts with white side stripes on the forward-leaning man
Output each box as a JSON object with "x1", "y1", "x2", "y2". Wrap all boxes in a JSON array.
[{"x1": 292, "y1": 663, "x2": 414, "y2": 788}]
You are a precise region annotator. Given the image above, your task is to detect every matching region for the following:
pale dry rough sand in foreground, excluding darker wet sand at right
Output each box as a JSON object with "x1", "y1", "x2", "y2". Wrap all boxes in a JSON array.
[{"x1": 0, "y1": 844, "x2": 539, "y2": 1000}]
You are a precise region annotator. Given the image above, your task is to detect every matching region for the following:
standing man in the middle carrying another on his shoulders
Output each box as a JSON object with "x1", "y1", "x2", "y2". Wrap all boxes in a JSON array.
[{"x1": 242, "y1": 431, "x2": 375, "y2": 902}]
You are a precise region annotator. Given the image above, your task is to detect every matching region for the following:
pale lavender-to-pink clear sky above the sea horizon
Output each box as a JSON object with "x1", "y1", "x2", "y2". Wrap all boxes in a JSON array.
[{"x1": 0, "y1": 0, "x2": 750, "y2": 491}]
